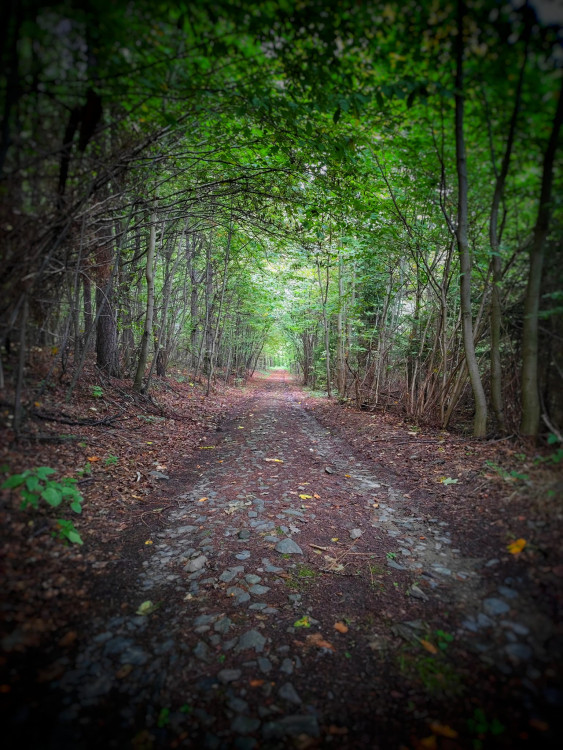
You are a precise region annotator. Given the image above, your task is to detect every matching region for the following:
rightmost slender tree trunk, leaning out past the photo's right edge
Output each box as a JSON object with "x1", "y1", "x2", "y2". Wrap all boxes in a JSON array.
[{"x1": 520, "y1": 78, "x2": 563, "y2": 437}]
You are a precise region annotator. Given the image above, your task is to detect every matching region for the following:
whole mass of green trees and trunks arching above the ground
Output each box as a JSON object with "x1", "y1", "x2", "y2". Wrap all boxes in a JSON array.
[{"x1": 0, "y1": 0, "x2": 563, "y2": 436}]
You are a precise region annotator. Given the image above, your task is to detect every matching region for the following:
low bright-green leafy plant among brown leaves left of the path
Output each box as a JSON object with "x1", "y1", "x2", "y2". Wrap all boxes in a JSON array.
[{"x1": 0, "y1": 466, "x2": 84, "y2": 544}]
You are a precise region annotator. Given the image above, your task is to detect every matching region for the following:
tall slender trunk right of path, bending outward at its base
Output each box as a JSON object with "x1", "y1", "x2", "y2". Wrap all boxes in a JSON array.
[{"x1": 455, "y1": 0, "x2": 487, "y2": 437}]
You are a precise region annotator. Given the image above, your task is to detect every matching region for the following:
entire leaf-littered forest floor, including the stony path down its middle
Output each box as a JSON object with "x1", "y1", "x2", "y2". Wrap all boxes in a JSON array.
[{"x1": 0, "y1": 371, "x2": 563, "y2": 750}]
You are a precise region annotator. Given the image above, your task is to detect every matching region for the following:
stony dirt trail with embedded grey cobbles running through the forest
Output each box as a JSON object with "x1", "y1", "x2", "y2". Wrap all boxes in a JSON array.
[{"x1": 6, "y1": 373, "x2": 553, "y2": 749}]
